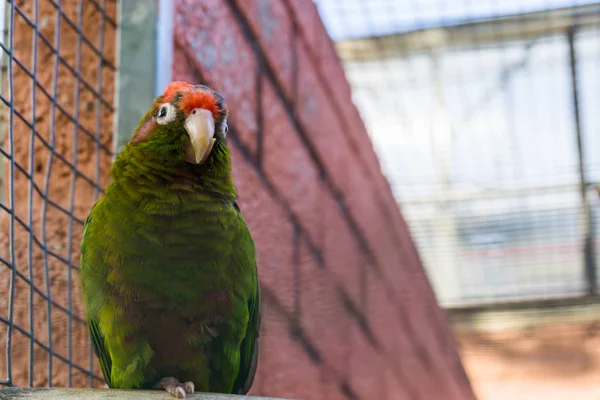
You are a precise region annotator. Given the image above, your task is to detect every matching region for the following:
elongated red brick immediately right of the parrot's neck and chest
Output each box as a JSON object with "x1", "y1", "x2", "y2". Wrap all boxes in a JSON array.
[{"x1": 230, "y1": 145, "x2": 296, "y2": 312}]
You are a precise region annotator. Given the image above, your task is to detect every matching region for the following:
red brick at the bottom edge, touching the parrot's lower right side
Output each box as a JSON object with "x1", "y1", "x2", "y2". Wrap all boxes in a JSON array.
[{"x1": 252, "y1": 304, "x2": 323, "y2": 399}]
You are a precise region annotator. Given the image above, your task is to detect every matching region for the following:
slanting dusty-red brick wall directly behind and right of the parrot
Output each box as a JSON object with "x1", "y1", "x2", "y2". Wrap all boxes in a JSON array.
[{"x1": 174, "y1": 0, "x2": 473, "y2": 399}]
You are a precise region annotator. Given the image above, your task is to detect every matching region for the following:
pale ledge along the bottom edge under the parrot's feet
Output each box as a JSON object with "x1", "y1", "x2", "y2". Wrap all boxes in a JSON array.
[{"x1": 0, "y1": 388, "x2": 285, "y2": 400}]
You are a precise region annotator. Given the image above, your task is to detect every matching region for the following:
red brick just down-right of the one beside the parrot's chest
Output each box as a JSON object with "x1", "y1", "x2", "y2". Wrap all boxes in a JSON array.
[{"x1": 300, "y1": 239, "x2": 355, "y2": 377}]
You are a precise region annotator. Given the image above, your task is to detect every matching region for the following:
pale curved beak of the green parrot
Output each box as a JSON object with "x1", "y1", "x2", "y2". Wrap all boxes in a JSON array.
[{"x1": 183, "y1": 108, "x2": 216, "y2": 164}]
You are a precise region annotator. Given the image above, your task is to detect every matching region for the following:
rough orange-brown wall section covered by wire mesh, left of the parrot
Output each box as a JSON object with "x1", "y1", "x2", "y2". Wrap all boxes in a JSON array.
[{"x1": 0, "y1": 0, "x2": 116, "y2": 386}]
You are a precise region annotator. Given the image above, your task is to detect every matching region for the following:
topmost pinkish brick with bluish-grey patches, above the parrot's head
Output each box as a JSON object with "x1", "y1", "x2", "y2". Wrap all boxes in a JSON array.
[{"x1": 173, "y1": 0, "x2": 259, "y2": 154}]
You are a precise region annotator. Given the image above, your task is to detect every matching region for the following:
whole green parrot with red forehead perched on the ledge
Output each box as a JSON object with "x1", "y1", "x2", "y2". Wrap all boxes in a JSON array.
[{"x1": 81, "y1": 82, "x2": 260, "y2": 398}]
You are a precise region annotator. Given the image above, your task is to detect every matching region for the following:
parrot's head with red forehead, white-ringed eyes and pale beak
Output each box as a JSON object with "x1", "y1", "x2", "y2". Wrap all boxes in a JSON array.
[{"x1": 130, "y1": 81, "x2": 228, "y2": 164}]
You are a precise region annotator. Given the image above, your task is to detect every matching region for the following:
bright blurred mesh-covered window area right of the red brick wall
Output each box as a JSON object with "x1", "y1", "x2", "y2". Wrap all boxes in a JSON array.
[{"x1": 317, "y1": 0, "x2": 600, "y2": 306}]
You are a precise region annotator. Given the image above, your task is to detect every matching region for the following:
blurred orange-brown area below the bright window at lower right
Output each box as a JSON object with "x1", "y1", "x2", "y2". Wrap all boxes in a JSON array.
[{"x1": 456, "y1": 320, "x2": 600, "y2": 400}]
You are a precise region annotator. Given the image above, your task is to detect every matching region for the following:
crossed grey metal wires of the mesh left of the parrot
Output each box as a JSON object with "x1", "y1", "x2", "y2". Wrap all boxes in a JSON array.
[{"x1": 0, "y1": 0, "x2": 117, "y2": 386}]
